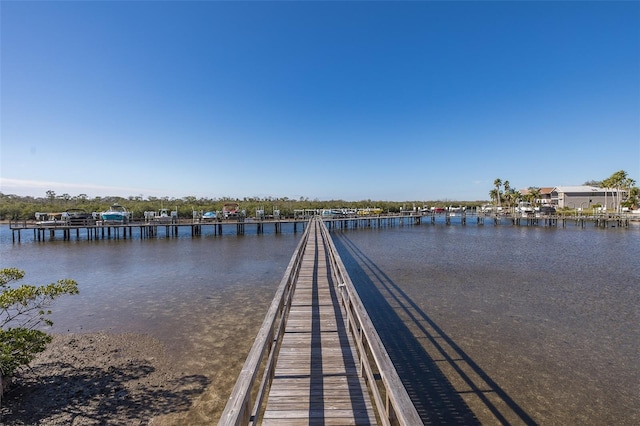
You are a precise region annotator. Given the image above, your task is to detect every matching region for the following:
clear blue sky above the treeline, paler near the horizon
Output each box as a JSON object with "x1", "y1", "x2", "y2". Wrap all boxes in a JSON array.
[{"x1": 0, "y1": 1, "x2": 640, "y2": 201}]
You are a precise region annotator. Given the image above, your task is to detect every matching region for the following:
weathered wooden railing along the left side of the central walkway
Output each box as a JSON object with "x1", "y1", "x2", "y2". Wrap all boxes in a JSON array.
[{"x1": 218, "y1": 221, "x2": 311, "y2": 426}]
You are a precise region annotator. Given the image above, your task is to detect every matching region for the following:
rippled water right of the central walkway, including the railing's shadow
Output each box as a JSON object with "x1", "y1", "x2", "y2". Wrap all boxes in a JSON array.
[{"x1": 334, "y1": 225, "x2": 640, "y2": 425}]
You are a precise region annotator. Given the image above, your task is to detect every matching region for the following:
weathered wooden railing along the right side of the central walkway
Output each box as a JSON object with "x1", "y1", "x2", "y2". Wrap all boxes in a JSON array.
[{"x1": 319, "y1": 220, "x2": 423, "y2": 426}]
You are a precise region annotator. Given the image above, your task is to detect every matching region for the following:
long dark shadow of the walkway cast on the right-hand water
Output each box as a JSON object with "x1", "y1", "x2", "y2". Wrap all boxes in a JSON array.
[{"x1": 333, "y1": 233, "x2": 536, "y2": 425}]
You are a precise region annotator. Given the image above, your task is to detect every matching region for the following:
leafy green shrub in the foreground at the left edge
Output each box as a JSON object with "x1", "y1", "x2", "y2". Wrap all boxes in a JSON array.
[{"x1": 0, "y1": 268, "x2": 78, "y2": 377}]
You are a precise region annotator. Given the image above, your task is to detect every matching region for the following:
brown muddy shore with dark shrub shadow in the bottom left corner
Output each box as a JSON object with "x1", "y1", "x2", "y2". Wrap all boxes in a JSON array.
[{"x1": 0, "y1": 333, "x2": 222, "y2": 425}]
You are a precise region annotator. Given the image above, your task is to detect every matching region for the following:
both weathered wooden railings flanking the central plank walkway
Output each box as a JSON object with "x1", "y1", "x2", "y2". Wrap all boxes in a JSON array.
[{"x1": 218, "y1": 217, "x2": 422, "y2": 426}]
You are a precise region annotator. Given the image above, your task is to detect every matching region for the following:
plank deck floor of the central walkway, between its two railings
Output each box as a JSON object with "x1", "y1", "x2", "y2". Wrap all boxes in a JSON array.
[{"x1": 262, "y1": 221, "x2": 376, "y2": 425}]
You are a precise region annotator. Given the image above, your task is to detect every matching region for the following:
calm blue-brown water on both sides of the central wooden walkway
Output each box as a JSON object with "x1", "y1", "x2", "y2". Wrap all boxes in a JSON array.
[{"x1": 0, "y1": 224, "x2": 640, "y2": 424}]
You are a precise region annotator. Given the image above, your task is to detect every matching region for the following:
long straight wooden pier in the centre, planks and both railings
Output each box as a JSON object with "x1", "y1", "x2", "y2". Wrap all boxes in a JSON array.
[{"x1": 219, "y1": 218, "x2": 422, "y2": 425}]
